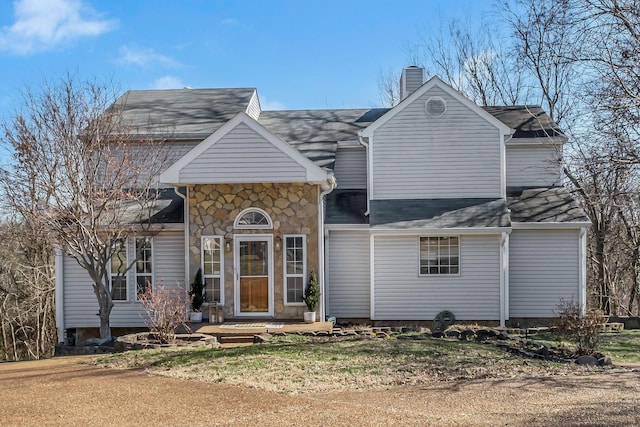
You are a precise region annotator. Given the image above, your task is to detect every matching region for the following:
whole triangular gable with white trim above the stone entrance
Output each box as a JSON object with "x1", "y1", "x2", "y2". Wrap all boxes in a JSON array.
[{"x1": 160, "y1": 113, "x2": 331, "y2": 184}]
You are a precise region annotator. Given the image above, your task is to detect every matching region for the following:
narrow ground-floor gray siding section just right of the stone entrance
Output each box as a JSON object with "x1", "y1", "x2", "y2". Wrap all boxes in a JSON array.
[{"x1": 326, "y1": 230, "x2": 371, "y2": 319}]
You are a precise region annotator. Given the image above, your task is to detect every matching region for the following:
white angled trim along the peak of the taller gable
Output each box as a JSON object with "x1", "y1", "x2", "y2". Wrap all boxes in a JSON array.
[{"x1": 362, "y1": 76, "x2": 514, "y2": 137}]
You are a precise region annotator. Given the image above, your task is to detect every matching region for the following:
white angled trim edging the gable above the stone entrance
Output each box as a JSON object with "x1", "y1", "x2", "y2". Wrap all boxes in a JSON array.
[{"x1": 160, "y1": 112, "x2": 333, "y2": 184}]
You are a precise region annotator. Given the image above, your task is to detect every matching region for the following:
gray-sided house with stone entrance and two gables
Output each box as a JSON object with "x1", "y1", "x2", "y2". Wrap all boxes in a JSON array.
[{"x1": 56, "y1": 67, "x2": 590, "y2": 342}]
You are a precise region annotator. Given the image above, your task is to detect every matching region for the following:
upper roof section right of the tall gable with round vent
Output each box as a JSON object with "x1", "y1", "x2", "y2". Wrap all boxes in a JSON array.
[{"x1": 482, "y1": 105, "x2": 563, "y2": 138}]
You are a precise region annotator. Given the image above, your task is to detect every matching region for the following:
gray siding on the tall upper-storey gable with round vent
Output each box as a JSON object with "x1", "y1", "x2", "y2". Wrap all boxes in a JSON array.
[{"x1": 371, "y1": 88, "x2": 501, "y2": 199}]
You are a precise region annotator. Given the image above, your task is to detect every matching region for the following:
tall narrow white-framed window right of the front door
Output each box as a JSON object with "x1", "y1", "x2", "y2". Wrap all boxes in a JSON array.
[{"x1": 284, "y1": 235, "x2": 307, "y2": 304}]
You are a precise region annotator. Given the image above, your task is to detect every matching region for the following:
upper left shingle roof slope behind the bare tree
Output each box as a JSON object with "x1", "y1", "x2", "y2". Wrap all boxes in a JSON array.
[{"x1": 115, "y1": 88, "x2": 256, "y2": 139}]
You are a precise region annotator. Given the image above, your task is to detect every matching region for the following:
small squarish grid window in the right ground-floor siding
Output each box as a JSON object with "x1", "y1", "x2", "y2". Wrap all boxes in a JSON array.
[{"x1": 420, "y1": 237, "x2": 460, "y2": 275}]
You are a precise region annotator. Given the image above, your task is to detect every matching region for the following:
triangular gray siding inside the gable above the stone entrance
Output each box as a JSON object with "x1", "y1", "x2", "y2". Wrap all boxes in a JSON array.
[{"x1": 180, "y1": 123, "x2": 307, "y2": 183}]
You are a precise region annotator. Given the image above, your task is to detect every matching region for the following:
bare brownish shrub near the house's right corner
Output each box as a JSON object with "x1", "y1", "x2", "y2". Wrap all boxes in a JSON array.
[{"x1": 556, "y1": 300, "x2": 607, "y2": 355}]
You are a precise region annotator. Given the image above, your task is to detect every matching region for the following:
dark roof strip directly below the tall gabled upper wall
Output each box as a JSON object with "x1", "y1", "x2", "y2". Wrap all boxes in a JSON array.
[{"x1": 370, "y1": 199, "x2": 511, "y2": 230}]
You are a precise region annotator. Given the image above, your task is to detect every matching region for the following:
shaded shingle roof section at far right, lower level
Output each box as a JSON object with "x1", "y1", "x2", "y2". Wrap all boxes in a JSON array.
[{"x1": 507, "y1": 187, "x2": 589, "y2": 223}]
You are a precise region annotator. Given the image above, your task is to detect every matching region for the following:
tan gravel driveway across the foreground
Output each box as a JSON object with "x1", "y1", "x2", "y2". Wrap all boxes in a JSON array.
[{"x1": 0, "y1": 357, "x2": 640, "y2": 426}]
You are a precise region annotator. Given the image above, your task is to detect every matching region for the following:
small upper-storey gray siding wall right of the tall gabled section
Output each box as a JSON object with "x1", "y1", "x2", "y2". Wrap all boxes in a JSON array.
[{"x1": 506, "y1": 146, "x2": 561, "y2": 187}]
